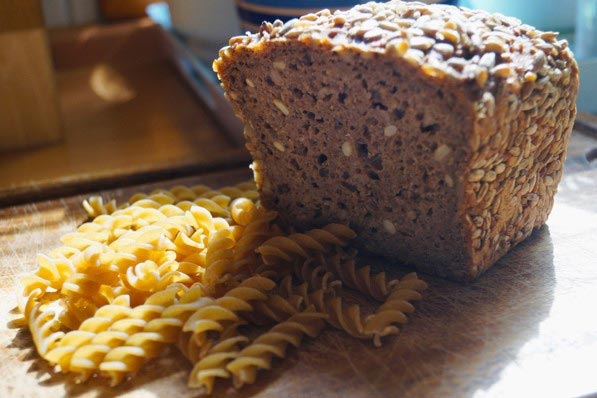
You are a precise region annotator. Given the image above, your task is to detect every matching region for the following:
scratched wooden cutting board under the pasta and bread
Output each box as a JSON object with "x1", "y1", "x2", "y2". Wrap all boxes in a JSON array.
[{"x1": 0, "y1": 135, "x2": 597, "y2": 398}]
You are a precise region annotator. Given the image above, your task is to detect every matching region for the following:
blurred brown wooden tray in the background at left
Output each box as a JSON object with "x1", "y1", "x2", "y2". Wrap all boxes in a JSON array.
[{"x1": 0, "y1": 20, "x2": 249, "y2": 206}]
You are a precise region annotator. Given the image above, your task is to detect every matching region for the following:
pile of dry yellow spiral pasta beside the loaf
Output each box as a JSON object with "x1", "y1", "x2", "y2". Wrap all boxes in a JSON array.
[{"x1": 18, "y1": 182, "x2": 426, "y2": 394}]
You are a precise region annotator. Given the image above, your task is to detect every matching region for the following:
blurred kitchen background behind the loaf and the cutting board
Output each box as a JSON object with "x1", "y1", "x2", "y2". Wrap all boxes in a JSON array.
[{"x1": 0, "y1": 0, "x2": 597, "y2": 206}]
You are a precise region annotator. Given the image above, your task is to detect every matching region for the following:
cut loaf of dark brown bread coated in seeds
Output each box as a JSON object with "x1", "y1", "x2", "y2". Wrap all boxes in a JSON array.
[{"x1": 214, "y1": 1, "x2": 578, "y2": 281}]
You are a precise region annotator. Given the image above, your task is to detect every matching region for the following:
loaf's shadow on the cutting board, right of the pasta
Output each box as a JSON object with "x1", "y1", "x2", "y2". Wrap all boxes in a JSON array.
[{"x1": 274, "y1": 226, "x2": 555, "y2": 398}]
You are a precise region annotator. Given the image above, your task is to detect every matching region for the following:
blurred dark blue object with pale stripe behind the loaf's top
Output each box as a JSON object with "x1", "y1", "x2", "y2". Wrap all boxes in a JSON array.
[{"x1": 236, "y1": 0, "x2": 458, "y2": 32}]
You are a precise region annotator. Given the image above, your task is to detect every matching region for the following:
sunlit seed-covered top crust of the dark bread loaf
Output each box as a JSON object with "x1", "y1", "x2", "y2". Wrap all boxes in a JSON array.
[{"x1": 214, "y1": 0, "x2": 578, "y2": 100}]
